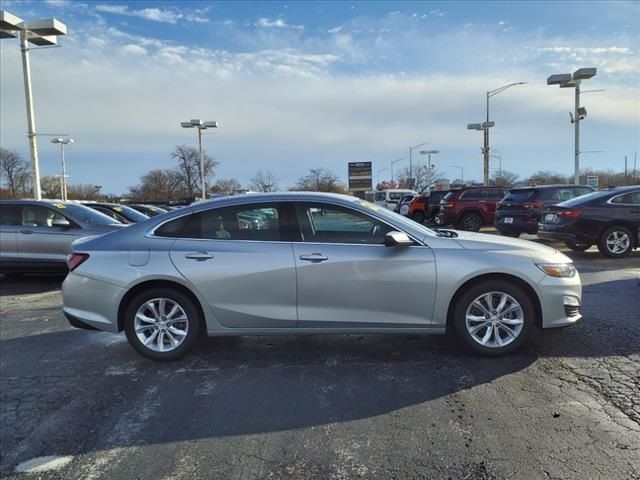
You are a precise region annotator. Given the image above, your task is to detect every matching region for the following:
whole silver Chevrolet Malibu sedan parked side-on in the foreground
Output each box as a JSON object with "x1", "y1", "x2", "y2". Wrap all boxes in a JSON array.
[{"x1": 63, "y1": 193, "x2": 582, "y2": 360}]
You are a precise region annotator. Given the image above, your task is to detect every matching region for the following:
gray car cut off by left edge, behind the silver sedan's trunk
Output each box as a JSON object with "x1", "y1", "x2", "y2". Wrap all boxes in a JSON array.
[{"x1": 0, "y1": 200, "x2": 124, "y2": 276}]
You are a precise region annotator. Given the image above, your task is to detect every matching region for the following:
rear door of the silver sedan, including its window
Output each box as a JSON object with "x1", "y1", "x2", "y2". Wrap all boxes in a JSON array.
[{"x1": 164, "y1": 203, "x2": 297, "y2": 329}]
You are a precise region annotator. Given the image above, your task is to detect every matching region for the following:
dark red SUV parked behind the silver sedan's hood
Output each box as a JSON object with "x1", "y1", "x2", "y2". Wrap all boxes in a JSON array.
[{"x1": 436, "y1": 187, "x2": 509, "y2": 232}]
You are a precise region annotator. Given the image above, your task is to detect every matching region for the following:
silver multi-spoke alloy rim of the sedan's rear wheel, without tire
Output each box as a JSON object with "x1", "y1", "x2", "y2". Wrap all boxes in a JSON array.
[{"x1": 133, "y1": 298, "x2": 189, "y2": 352}]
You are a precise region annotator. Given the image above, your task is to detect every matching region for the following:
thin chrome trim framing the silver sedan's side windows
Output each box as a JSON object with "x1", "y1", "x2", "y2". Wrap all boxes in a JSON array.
[{"x1": 144, "y1": 199, "x2": 430, "y2": 248}]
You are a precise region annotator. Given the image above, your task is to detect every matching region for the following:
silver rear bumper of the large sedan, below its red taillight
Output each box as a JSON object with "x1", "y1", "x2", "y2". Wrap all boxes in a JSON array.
[{"x1": 62, "y1": 272, "x2": 125, "y2": 332}]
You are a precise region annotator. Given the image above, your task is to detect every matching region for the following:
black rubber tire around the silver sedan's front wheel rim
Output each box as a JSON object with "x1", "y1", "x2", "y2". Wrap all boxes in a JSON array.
[{"x1": 451, "y1": 280, "x2": 536, "y2": 357}]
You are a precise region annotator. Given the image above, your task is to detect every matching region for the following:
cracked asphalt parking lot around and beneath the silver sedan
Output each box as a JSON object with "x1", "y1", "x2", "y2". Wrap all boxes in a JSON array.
[{"x1": 0, "y1": 238, "x2": 640, "y2": 480}]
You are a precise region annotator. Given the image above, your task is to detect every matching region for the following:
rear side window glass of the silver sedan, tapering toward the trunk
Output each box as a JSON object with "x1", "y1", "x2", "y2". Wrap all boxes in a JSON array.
[{"x1": 155, "y1": 204, "x2": 281, "y2": 242}]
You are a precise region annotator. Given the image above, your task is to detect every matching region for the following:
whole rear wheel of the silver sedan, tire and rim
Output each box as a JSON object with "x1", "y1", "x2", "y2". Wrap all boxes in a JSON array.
[{"x1": 124, "y1": 288, "x2": 203, "y2": 361}]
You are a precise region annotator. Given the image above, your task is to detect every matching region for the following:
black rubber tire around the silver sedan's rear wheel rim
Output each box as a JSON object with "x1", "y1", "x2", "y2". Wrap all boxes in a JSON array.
[{"x1": 123, "y1": 288, "x2": 204, "y2": 361}]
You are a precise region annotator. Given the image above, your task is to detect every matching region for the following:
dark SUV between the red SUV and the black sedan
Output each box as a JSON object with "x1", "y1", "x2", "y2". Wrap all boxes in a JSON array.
[{"x1": 495, "y1": 185, "x2": 595, "y2": 237}]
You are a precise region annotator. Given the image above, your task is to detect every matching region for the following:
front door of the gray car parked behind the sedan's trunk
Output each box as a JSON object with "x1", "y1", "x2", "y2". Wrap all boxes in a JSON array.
[{"x1": 17, "y1": 203, "x2": 83, "y2": 263}]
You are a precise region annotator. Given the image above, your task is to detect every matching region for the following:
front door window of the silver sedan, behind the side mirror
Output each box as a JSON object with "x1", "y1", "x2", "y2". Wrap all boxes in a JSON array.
[{"x1": 296, "y1": 204, "x2": 393, "y2": 245}]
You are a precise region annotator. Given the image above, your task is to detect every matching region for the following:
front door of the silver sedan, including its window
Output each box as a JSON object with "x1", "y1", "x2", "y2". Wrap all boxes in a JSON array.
[{"x1": 293, "y1": 202, "x2": 436, "y2": 328}]
